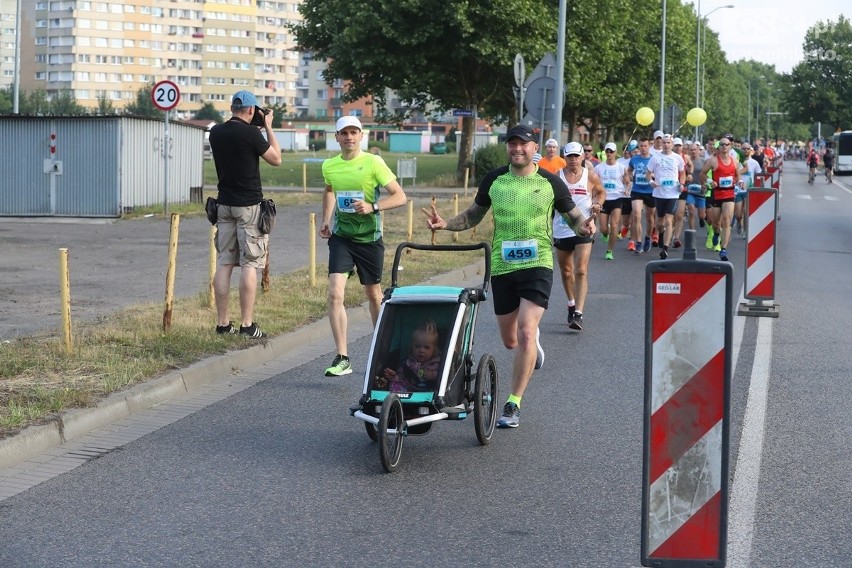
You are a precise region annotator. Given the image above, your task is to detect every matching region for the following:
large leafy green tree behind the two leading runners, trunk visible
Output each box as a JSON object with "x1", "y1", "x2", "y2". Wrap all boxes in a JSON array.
[{"x1": 292, "y1": 0, "x2": 556, "y2": 179}]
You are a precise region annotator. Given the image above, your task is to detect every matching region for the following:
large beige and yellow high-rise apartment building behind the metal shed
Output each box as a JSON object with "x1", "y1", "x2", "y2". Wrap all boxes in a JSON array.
[{"x1": 17, "y1": 0, "x2": 301, "y2": 118}]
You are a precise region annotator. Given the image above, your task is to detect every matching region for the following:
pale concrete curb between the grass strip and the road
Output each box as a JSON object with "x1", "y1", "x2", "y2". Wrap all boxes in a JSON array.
[{"x1": 0, "y1": 261, "x2": 485, "y2": 469}]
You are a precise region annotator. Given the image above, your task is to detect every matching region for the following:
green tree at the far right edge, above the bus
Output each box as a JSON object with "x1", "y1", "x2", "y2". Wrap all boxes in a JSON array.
[{"x1": 783, "y1": 15, "x2": 852, "y2": 128}]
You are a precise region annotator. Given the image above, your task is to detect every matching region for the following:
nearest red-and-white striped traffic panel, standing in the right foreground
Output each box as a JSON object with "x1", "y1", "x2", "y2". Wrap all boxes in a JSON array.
[{"x1": 641, "y1": 230, "x2": 733, "y2": 568}]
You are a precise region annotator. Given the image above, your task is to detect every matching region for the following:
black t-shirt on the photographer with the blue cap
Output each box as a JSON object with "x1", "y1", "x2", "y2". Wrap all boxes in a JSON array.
[{"x1": 210, "y1": 117, "x2": 269, "y2": 207}]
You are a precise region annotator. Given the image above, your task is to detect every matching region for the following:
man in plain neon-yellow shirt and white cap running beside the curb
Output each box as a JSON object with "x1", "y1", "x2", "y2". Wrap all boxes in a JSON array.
[{"x1": 320, "y1": 116, "x2": 406, "y2": 377}]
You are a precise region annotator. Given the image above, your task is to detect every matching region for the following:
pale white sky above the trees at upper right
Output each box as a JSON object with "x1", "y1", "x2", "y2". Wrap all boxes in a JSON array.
[{"x1": 694, "y1": 0, "x2": 852, "y2": 73}]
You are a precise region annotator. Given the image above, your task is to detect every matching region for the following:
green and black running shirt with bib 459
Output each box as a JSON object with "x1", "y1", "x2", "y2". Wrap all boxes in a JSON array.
[{"x1": 474, "y1": 165, "x2": 576, "y2": 276}]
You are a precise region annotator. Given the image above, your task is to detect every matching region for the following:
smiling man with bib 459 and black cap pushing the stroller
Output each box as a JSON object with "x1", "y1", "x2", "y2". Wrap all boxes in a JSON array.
[{"x1": 424, "y1": 124, "x2": 595, "y2": 428}]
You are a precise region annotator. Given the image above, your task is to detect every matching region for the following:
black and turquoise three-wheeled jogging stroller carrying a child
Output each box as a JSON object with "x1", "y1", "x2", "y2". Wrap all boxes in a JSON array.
[{"x1": 350, "y1": 242, "x2": 497, "y2": 472}]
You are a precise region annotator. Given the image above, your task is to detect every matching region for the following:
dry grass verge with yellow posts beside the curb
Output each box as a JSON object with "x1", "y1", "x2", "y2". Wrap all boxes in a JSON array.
[{"x1": 0, "y1": 194, "x2": 492, "y2": 438}]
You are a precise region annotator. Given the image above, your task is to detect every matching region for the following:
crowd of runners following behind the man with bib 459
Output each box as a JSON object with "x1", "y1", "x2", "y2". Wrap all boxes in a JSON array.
[{"x1": 538, "y1": 130, "x2": 784, "y2": 331}]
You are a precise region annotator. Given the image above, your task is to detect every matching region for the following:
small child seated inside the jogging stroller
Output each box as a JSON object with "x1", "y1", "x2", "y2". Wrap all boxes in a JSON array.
[{"x1": 376, "y1": 320, "x2": 441, "y2": 392}]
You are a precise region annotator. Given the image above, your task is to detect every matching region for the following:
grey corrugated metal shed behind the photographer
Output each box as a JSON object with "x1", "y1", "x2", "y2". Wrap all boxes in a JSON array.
[{"x1": 0, "y1": 116, "x2": 204, "y2": 217}]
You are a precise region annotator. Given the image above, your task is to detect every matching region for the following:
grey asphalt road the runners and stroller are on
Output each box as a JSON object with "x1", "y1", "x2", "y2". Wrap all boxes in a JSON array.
[{"x1": 0, "y1": 164, "x2": 852, "y2": 568}]
